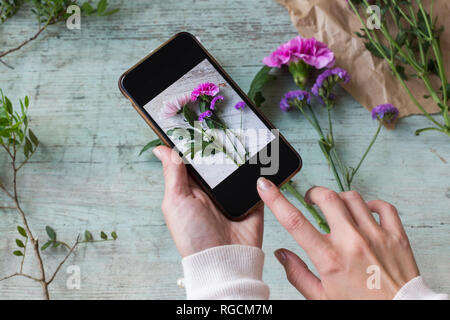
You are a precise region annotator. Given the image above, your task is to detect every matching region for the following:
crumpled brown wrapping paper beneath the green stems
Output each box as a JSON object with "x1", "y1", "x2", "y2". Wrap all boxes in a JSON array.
[{"x1": 276, "y1": 0, "x2": 450, "y2": 127}]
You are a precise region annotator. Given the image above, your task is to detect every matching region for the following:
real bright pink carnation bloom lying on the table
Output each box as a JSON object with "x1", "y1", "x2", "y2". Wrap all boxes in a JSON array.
[{"x1": 263, "y1": 36, "x2": 335, "y2": 69}]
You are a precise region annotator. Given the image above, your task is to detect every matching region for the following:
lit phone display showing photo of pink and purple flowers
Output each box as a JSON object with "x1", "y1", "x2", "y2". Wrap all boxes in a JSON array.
[{"x1": 144, "y1": 59, "x2": 275, "y2": 189}]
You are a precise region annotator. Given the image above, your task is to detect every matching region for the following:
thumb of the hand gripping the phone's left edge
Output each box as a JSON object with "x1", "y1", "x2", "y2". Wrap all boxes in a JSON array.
[{"x1": 153, "y1": 146, "x2": 191, "y2": 202}]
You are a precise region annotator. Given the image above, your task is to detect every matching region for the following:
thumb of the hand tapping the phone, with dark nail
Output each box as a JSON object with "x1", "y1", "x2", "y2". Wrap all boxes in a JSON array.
[{"x1": 274, "y1": 249, "x2": 324, "y2": 300}]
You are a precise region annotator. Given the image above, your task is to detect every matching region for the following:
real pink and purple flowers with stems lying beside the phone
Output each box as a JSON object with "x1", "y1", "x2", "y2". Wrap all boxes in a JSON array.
[{"x1": 249, "y1": 36, "x2": 398, "y2": 232}]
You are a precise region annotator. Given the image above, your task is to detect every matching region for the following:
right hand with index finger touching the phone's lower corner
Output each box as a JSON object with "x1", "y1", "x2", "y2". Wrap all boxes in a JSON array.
[{"x1": 258, "y1": 178, "x2": 419, "y2": 299}]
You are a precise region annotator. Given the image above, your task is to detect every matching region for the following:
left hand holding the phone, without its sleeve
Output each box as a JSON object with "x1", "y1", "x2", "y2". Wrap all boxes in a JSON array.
[{"x1": 154, "y1": 147, "x2": 264, "y2": 257}]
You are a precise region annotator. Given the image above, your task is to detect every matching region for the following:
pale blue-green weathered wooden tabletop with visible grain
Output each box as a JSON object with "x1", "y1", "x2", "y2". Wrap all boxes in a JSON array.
[{"x1": 0, "y1": 0, "x2": 450, "y2": 299}]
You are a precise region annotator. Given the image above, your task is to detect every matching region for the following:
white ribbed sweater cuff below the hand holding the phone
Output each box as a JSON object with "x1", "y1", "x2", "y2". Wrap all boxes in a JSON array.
[{"x1": 182, "y1": 245, "x2": 269, "y2": 300}]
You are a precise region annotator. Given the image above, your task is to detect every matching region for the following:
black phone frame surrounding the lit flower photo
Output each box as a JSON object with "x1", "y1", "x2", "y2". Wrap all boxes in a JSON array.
[{"x1": 119, "y1": 32, "x2": 302, "y2": 220}]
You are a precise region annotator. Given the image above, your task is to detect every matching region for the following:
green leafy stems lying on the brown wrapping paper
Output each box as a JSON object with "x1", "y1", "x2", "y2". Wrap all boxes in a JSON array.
[{"x1": 349, "y1": 0, "x2": 450, "y2": 136}]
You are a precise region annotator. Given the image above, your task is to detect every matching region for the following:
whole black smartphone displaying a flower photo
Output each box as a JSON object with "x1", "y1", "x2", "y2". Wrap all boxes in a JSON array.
[{"x1": 119, "y1": 32, "x2": 302, "y2": 220}]
